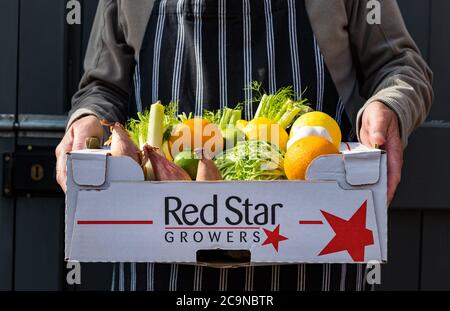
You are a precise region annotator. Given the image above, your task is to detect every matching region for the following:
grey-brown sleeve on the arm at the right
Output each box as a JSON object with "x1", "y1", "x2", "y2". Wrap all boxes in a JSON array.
[{"x1": 349, "y1": 0, "x2": 433, "y2": 147}]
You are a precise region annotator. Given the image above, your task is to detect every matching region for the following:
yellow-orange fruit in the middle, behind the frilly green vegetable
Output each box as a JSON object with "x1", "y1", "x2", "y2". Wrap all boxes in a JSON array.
[{"x1": 244, "y1": 117, "x2": 289, "y2": 150}]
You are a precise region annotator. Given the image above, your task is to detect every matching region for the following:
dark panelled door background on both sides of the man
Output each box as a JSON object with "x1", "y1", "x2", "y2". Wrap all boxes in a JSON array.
[{"x1": 0, "y1": 0, "x2": 450, "y2": 290}]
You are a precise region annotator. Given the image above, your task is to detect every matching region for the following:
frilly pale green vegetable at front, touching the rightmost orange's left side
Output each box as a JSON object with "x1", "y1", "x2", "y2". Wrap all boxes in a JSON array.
[{"x1": 215, "y1": 140, "x2": 286, "y2": 180}]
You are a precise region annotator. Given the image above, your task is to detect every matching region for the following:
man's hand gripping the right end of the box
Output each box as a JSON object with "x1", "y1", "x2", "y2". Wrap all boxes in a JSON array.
[{"x1": 359, "y1": 102, "x2": 403, "y2": 206}]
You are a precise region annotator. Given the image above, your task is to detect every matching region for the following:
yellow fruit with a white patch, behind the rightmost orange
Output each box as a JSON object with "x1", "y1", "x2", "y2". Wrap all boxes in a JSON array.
[{"x1": 288, "y1": 111, "x2": 342, "y2": 150}]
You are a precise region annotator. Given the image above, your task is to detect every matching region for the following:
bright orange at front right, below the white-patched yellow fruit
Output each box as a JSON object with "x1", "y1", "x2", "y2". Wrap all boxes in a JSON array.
[{"x1": 284, "y1": 136, "x2": 339, "y2": 180}]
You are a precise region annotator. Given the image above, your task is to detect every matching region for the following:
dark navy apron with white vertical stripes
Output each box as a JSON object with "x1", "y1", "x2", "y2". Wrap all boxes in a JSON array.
[{"x1": 111, "y1": 0, "x2": 368, "y2": 291}]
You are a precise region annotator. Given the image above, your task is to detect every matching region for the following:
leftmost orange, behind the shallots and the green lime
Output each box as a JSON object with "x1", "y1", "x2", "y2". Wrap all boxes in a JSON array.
[{"x1": 169, "y1": 118, "x2": 223, "y2": 157}]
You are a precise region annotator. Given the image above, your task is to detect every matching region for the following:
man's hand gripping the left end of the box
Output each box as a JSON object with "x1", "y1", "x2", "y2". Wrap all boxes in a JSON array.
[{"x1": 55, "y1": 116, "x2": 103, "y2": 192}]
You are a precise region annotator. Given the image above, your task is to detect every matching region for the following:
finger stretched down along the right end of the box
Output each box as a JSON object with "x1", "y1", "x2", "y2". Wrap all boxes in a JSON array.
[{"x1": 385, "y1": 124, "x2": 403, "y2": 205}]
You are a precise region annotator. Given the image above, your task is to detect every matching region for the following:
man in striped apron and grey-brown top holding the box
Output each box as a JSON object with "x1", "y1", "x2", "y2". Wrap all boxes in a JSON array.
[{"x1": 56, "y1": 0, "x2": 432, "y2": 290}]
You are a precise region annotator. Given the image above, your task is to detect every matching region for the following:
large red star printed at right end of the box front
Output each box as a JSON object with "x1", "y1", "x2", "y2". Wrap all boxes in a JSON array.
[{"x1": 319, "y1": 201, "x2": 374, "y2": 261}]
